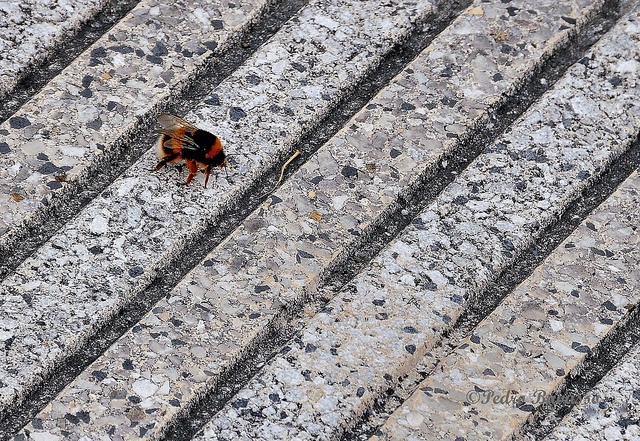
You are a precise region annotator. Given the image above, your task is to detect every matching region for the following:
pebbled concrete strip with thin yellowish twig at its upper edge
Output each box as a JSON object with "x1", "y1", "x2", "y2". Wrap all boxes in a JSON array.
[{"x1": 15, "y1": 2, "x2": 620, "y2": 438}]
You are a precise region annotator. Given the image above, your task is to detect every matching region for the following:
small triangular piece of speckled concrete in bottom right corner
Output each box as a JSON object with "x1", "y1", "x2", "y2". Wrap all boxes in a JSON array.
[{"x1": 545, "y1": 334, "x2": 640, "y2": 441}]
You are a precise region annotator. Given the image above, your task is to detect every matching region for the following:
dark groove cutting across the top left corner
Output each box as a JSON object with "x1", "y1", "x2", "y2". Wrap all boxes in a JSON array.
[{"x1": 0, "y1": 0, "x2": 140, "y2": 123}]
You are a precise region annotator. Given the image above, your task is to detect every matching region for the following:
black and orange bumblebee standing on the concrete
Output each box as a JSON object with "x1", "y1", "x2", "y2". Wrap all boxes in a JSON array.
[{"x1": 153, "y1": 113, "x2": 227, "y2": 188}]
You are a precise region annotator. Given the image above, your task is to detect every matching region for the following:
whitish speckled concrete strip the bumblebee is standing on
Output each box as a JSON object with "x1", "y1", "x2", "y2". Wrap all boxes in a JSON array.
[{"x1": 0, "y1": 1, "x2": 450, "y2": 430}]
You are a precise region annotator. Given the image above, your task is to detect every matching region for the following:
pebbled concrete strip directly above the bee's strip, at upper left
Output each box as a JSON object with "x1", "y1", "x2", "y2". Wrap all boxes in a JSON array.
[{"x1": 0, "y1": 0, "x2": 266, "y2": 241}]
